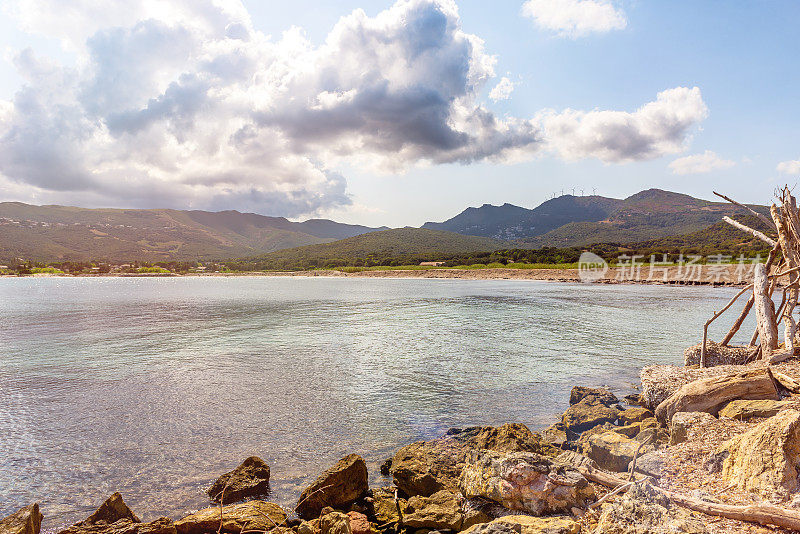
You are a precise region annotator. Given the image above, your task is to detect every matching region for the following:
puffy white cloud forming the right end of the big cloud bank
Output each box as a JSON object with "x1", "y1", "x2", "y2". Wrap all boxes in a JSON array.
[{"x1": 541, "y1": 87, "x2": 708, "y2": 163}]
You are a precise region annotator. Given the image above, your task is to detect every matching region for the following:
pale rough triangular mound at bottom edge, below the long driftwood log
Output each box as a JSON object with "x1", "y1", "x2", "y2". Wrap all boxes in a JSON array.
[{"x1": 595, "y1": 480, "x2": 708, "y2": 534}]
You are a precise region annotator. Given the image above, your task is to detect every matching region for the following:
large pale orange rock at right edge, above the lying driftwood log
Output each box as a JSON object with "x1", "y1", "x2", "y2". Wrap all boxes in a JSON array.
[{"x1": 718, "y1": 410, "x2": 800, "y2": 497}]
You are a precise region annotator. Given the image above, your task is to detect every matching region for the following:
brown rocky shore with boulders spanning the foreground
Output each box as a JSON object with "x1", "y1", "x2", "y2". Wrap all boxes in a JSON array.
[{"x1": 0, "y1": 349, "x2": 800, "y2": 534}]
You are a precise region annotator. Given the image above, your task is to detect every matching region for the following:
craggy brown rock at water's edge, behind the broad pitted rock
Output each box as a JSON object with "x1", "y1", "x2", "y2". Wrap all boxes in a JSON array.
[{"x1": 392, "y1": 423, "x2": 560, "y2": 496}]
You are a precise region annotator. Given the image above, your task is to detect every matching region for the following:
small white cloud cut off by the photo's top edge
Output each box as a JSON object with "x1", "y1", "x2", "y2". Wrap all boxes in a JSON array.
[{"x1": 522, "y1": 0, "x2": 628, "y2": 39}]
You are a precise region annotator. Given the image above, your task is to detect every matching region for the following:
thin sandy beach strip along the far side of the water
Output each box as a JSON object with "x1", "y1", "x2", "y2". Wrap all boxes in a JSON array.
[{"x1": 0, "y1": 265, "x2": 764, "y2": 287}]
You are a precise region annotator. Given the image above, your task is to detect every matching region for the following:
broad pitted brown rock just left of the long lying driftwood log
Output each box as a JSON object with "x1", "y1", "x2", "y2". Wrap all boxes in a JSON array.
[{"x1": 460, "y1": 451, "x2": 594, "y2": 515}]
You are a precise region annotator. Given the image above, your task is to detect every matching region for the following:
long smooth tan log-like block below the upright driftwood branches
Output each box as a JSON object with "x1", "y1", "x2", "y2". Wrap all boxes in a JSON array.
[{"x1": 655, "y1": 369, "x2": 780, "y2": 424}]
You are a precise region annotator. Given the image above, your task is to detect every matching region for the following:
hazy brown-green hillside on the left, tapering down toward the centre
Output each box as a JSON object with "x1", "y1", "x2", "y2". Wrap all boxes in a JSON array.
[{"x1": 0, "y1": 202, "x2": 382, "y2": 262}]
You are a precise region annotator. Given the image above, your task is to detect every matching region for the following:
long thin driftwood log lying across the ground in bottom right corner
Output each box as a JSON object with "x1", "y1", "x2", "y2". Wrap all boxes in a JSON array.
[{"x1": 575, "y1": 465, "x2": 800, "y2": 530}]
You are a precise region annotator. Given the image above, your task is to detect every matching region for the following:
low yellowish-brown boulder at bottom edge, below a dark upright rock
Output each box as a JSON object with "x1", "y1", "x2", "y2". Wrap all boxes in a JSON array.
[{"x1": 175, "y1": 501, "x2": 286, "y2": 534}]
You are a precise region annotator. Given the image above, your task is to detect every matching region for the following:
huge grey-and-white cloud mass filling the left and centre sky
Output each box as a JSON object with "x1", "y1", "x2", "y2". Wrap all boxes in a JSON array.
[{"x1": 0, "y1": 0, "x2": 706, "y2": 216}]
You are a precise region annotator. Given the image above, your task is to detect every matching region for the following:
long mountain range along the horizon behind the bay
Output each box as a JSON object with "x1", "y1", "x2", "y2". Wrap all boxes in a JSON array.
[{"x1": 0, "y1": 189, "x2": 769, "y2": 262}]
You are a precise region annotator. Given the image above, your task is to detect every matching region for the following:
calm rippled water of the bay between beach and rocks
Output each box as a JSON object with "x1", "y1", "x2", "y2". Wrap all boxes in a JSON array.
[{"x1": 0, "y1": 277, "x2": 753, "y2": 529}]
